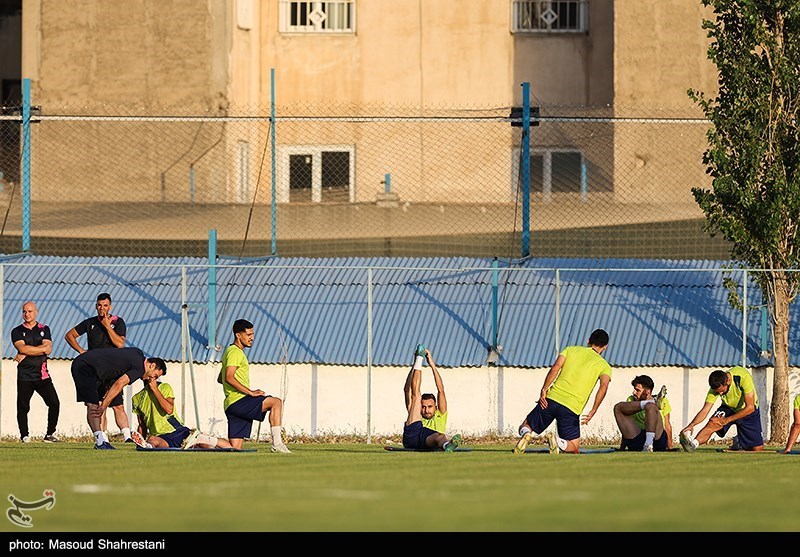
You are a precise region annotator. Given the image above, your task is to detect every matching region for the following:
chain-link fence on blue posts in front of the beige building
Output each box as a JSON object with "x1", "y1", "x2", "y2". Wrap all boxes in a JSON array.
[{"x1": 0, "y1": 101, "x2": 729, "y2": 259}]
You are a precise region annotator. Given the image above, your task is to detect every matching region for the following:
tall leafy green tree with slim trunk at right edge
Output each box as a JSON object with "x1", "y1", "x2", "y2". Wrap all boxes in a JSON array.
[{"x1": 689, "y1": 0, "x2": 800, "y2": 442}]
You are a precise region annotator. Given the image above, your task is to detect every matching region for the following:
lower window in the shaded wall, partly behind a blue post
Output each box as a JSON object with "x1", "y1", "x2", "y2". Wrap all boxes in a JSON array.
[{"x1": 512, "y1": 149, "x2": 587, "y2": 201}]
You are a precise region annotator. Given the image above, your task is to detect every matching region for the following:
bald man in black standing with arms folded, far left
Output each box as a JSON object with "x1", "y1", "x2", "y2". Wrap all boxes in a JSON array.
[{"x1": 11, "y1": 302, "x2": 61, "y2": 443}]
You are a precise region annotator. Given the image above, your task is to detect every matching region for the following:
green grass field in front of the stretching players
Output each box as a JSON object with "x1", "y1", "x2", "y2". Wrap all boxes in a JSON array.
[{"x1": 0, "y1": 442, "x2": 800, "y2": 533}]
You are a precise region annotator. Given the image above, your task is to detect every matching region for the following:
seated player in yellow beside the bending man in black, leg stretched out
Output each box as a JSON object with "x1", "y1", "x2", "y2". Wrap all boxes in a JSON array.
[{"x1": 131, "y1": 370, "x2": 231, "y2": 449}]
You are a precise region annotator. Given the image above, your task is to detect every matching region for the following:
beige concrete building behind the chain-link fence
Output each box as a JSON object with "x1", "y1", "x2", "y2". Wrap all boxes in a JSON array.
[{"x1": 0, "y1": 0, "x2": 715, "y2": 258}]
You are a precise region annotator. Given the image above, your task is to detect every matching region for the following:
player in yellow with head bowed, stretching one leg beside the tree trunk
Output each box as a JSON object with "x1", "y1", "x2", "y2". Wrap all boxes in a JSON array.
[{"x1": 680, "y1": 366, "x2": 764, "y2": 452}]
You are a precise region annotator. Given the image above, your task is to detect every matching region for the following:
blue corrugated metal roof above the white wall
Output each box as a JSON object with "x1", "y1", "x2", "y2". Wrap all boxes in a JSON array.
[{"x1": 0, "y1": 255, "x2": 788, "y2": 367}]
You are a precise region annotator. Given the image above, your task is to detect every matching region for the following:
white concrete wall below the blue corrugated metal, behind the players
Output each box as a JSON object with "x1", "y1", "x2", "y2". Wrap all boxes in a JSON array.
[{"x1": 0, "y1": 360, "x2": 800, "y2": 442}]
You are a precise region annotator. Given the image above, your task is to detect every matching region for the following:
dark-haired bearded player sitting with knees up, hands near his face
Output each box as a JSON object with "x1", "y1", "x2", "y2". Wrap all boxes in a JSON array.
[{"x1": 614, "y1": 375, "x2": 672, "y2": 452}]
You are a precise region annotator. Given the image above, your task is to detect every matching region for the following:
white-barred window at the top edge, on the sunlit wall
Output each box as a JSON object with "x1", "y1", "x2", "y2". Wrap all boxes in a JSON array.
[{"x1": 279, "y1": 0, "x2": 356, "y2": 33}]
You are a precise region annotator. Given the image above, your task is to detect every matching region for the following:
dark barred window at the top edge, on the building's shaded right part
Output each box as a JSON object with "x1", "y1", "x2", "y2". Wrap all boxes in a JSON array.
[{"x1": 511, "y1": 0, "x2": 589, "y2": 33}]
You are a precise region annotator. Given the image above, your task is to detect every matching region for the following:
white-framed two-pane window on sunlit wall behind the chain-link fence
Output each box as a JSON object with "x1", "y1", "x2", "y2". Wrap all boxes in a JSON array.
[{"x1": 278, "y1": 145, "x2": 355, "y2": 203}]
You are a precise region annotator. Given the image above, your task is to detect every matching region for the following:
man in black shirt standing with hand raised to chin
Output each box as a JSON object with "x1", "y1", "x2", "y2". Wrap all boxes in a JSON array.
[{"x1": 64, "y1": 292, "x2": 133, "y2": 443}]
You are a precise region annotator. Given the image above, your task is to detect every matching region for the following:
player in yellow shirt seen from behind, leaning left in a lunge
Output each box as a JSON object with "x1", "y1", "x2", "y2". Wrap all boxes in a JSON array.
[{"x1": 514, "y1": 329, "x2": 611, "y2": 454}]
